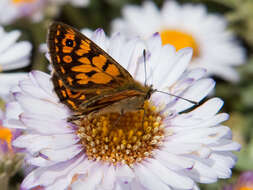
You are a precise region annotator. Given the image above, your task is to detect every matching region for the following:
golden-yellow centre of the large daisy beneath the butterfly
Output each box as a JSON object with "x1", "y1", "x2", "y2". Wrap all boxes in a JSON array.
[{"x1": 77, "y1": 102, "x2": 164, "y2": 166}]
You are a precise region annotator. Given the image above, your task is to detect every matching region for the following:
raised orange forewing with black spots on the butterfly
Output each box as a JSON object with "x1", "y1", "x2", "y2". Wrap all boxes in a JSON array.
[{"x1": 48, "y1": 22, "x2": 134, "y2": 90}]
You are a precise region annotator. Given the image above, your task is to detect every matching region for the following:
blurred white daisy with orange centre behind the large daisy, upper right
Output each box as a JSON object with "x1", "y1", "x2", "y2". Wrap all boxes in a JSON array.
[{"x1": 112, "y1": 1, "x2": 245, "y2": 82}]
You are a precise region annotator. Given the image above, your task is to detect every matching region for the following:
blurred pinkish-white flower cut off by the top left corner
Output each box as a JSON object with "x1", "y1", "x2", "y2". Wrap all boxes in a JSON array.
[{"x1": 0, "y1": 0, "x2": 89, "y2": 24}]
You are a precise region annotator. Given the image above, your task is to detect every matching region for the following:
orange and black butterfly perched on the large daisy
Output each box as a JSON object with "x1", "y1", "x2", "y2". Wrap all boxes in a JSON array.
[{"x1": 47, "y1": 22, "x2": 155, "y2": 115}]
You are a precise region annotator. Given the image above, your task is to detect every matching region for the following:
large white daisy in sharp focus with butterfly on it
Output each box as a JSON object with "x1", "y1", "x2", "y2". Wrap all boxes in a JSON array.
[{"x1": 5, "y1": 29, "x2": 240, "y2": 190}]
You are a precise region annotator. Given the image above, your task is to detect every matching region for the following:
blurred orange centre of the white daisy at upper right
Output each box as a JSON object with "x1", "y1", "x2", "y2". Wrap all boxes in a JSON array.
[{"x1": 160, "y1": 30, "x2": 199, "y2": 58}]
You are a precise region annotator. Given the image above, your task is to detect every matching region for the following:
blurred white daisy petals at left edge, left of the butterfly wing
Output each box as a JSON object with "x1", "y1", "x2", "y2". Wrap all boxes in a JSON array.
[{"x1": 0, "y1": 26, "x2": 32, "y2": 100}]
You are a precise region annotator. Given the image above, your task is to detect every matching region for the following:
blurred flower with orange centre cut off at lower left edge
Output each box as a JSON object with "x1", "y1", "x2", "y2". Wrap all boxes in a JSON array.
[{"x1": 0, "y1": 107, "x2": 23, "y2": 189}]
